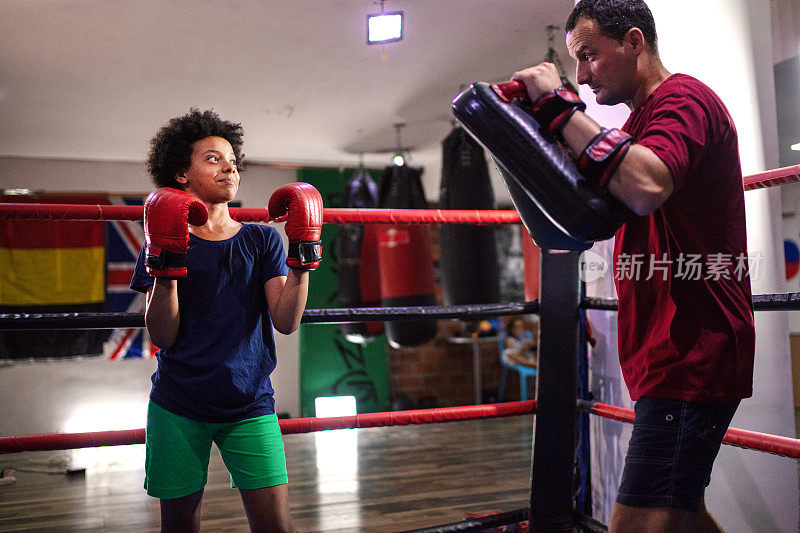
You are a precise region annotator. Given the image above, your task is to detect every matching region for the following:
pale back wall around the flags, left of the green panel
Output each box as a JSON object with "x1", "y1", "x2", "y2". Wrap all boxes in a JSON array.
[{"x1": 0, "y1": 157, "x2": 300, "y2": 435}]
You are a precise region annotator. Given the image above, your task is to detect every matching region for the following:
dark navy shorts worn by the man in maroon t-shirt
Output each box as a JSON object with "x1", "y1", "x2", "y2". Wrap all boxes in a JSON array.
[{"x1": 617, "y1": 398, "x2": 739, "y2": 511}]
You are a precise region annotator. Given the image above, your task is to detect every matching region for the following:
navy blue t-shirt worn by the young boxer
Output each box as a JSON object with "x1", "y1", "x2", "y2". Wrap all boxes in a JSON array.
[{"x1": 130, "y1": 224, "x2": 288, "y2": 422}]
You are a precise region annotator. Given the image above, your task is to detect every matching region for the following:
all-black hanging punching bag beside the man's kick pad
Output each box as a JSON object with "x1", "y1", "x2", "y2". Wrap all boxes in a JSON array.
[{"x1": 439, "y1": 127, "x2": 500, "y2": 305}]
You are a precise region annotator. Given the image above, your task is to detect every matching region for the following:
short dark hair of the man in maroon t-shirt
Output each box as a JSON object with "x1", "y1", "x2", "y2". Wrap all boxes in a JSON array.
[{"x1": 565, "y1": 0, "x2": 658, "y2": 55}]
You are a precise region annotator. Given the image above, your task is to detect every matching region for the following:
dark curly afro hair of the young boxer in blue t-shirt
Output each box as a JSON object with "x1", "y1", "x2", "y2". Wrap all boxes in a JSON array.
[{"x1": 147, "y1": 107, "x2": 244, "y2": 189}]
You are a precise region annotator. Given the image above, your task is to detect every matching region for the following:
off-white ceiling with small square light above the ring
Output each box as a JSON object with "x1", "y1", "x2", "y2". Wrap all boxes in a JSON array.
[{"x1": 0, "y1": 0, "x2": 573, "y2": 175}]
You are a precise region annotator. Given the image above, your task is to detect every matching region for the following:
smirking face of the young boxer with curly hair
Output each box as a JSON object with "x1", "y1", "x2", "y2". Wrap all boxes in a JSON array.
[{"x1": 180, "y1": 137, "x2": 239, "y2": 204}]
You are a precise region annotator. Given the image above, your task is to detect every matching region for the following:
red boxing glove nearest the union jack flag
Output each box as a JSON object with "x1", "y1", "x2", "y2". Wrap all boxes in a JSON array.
[{"x1": 144, "y1": 187, "x2": 208, "y2": 278}]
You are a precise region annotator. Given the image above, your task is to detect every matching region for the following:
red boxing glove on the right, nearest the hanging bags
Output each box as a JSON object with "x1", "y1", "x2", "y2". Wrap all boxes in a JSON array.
[{"x1": 267, "y1": 183, "x2": 322, "y2": 270}]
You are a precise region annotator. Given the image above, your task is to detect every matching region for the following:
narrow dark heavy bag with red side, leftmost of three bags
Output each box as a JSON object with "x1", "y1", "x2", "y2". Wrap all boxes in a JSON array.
[{"x1": 336, "y1": 169, "x2": 383, "y2": 344}]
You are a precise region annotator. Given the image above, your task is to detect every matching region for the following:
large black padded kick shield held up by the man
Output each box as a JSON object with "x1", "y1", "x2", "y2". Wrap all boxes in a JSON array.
[{"x1": 452, "y1": 83, "x2": 635, "y2": 251}]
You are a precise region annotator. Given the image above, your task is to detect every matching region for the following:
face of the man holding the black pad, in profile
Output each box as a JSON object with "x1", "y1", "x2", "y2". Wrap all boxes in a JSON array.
[{"x1": 567, "y1": 17, "x2": 636, "y2": 105}]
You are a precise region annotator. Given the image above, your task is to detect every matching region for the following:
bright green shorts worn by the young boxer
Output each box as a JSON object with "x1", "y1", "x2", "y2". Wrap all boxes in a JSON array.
[{"x1": 144, "y1": 401, "x2": 288, "y2": 499}]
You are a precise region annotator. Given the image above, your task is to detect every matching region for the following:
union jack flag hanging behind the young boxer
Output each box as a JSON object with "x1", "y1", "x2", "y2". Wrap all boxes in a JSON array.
[{"x1": 103, "y1": 196, "x2": 158, "y2": 359}]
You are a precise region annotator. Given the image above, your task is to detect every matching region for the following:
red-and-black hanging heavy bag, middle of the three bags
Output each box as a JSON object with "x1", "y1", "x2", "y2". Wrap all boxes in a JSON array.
[{"x1": 377, "y1": 166, "x2": 437, "y2": 348}]
